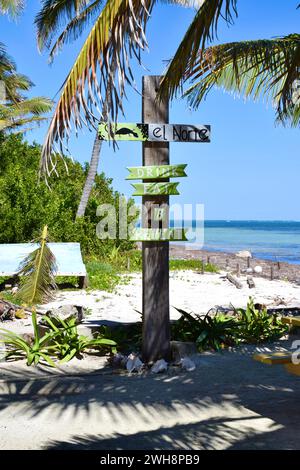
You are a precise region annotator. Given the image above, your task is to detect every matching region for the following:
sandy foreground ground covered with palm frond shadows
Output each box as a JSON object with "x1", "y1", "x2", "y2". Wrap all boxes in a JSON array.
[{"x1": 0, "y1": 340, "x2": 300, "y2": 450}]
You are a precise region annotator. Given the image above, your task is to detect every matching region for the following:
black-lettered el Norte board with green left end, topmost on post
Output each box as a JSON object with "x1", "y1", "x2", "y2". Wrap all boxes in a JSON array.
[{"x1": 99, "y1": 123, "x2": 211, "y2": 143}]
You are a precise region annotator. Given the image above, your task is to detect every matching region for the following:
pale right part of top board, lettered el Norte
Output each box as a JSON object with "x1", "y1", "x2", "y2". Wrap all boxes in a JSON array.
[{"x1": 148, "y1": 124, "x2": 210, "y2": 142}]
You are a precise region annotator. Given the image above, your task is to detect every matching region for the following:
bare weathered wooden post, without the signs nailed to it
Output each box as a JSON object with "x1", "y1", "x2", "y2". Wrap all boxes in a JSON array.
[{"x1": 142, "y1": 76, "x2": 170, "y2": 362}]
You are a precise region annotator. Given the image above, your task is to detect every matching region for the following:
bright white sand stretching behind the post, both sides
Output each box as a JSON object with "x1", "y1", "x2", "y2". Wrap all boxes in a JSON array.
[{"x1": 37, "y1": 271, "x2": 300, "y2": 322}]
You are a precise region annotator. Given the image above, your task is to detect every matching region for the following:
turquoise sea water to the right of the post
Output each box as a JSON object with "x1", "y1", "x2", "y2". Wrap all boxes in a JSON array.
[{"x1": 178, "y1": 220, "x2": 300, "y2": 264}]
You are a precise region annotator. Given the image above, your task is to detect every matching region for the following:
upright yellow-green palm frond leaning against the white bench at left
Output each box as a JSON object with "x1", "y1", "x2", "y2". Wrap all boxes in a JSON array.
[{"x1": 18, "y1": 225, "x2": 57, "y2": 305}]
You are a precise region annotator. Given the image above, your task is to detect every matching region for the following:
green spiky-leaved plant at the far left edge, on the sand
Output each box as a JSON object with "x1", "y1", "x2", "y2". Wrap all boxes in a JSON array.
[{"x1": 0, "y1": 311, "x2": 55, "y2": 367}]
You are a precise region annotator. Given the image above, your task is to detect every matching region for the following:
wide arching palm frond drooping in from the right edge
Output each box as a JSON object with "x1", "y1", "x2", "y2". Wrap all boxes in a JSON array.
[{"x1": 185, "y1": 34, "x2": 300, "y2": 125}]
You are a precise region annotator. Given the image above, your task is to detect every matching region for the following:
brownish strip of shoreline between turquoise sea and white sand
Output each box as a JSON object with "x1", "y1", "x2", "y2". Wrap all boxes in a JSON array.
[{"x1": 170, "y1": 245, "x2": 300, "y2": 285}]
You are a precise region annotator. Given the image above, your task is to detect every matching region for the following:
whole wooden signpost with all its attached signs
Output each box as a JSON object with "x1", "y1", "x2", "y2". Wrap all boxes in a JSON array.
[{"x1": 99, "y1": 76, "x2": 211, "y2": 363}]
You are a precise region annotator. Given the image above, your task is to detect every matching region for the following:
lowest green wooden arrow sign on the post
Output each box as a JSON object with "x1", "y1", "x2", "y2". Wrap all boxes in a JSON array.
[{"x1": 129, "y1": 228, "x2": 187, "y2": 242}]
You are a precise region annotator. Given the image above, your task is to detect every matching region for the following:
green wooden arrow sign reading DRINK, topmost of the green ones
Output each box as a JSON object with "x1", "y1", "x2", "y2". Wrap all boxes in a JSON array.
[{"x1": 126, "y1": 163, "x2": 187, "y2": 180}]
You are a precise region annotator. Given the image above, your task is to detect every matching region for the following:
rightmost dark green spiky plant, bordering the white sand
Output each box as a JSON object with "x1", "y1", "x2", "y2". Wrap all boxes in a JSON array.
[{"x1": 234, "y1": 297, "x2": 288, "y2": 343}]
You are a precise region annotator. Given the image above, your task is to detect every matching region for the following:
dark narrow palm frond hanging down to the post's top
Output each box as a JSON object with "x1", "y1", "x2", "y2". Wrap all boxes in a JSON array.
[{"x1": 159, "y1": 0, "x2": 237, "y2": 98}]
